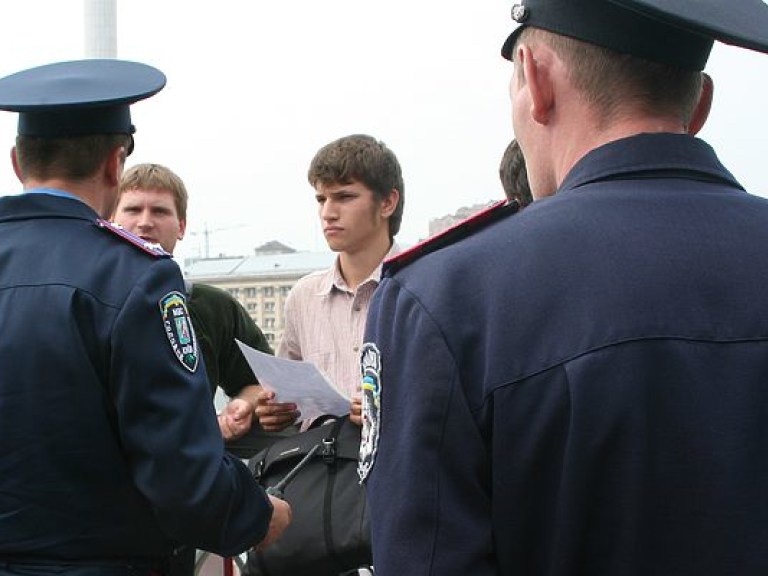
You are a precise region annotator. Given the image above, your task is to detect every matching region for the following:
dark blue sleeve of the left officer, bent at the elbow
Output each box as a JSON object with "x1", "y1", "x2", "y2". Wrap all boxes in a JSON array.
[{"x1": 110, "y1": 260, "x2": 271, "y2": 556}]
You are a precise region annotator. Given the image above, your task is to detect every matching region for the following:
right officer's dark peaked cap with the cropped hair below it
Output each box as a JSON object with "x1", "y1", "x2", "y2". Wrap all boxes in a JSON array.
[{"x1": 501, "y1": 0, "x2": 768, "y2": 126}]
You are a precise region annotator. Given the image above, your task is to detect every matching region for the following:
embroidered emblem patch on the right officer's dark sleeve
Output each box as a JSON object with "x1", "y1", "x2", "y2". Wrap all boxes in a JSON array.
[{"x1": 357, "y1": 342, "x2": 381, "y2": 484}]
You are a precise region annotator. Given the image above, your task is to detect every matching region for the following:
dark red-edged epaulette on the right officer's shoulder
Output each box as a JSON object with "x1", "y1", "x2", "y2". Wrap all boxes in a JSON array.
[{"x1": 382, "y1": 200, "x2": 520, "y2": 276}]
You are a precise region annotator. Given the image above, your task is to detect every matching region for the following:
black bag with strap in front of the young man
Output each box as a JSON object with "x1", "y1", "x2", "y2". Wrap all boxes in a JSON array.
[{"x1": 244, "y1": 416, "x2": 372, "y2": 576}]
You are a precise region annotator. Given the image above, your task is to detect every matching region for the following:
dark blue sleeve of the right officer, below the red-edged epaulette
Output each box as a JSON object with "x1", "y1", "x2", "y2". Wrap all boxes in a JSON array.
[{"x1": 361, "y1": 279, "x2": 497, "y2": 576}]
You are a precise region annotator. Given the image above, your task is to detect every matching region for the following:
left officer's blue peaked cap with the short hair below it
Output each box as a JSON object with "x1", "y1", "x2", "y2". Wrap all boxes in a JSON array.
[{"x1": 0, "y1": 59, "x2": 165, "y2": 180}]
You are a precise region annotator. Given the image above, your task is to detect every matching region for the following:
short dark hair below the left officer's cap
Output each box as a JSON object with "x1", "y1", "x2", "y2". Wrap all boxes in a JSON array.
[{"x1": 16, "y1": 134, "x2": 131, "y2": 180}]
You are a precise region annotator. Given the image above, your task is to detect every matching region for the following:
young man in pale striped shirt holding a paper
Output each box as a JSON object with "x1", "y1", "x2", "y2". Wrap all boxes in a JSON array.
[{"x1": 256, "y1": 134, "x2": 405, "y2": 430}]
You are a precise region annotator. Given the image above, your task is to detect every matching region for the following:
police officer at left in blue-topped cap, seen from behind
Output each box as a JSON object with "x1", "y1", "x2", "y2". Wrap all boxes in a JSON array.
[{"x1": 0, "y1": 60, "x2": 290, "y2": 576}]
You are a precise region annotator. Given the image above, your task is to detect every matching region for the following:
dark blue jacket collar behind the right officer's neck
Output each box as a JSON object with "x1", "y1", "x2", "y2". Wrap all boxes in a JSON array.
[{"x1": 557, "y1": 133, "x2": 743, "y2": 194}]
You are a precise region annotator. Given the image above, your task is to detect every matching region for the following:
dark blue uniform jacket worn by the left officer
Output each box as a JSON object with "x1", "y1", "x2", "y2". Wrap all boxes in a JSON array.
[{"x1": 0, "y1": 194, "x2": 271, "y2": 563}]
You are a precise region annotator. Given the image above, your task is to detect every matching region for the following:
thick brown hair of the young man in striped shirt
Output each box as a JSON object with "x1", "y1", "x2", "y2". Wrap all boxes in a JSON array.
[{"x1": 307, "y1": 134, "x2": 405, "y2": 238}]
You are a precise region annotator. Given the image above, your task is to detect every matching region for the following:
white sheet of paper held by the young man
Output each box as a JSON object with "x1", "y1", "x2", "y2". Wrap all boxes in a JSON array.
[{"x1": 235, "y1": 339, "x2": 350, "y2": 420}]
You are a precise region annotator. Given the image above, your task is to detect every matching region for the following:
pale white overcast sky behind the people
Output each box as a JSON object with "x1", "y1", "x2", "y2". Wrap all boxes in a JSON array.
[{"x1": 0, "y1": 0, "x2": 768, "y2": 258}]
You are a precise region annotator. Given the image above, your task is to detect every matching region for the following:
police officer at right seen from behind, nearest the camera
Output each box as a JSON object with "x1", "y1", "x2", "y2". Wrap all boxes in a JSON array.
[{"x1": 360, "y1": 0, "x2": 768, "y2": 576}]
